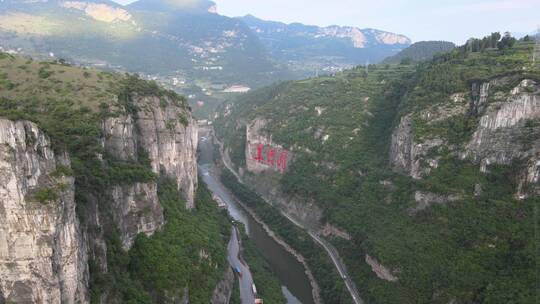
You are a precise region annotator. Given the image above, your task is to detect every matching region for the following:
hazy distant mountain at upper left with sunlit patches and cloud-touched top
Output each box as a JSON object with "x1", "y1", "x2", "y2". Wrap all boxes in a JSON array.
[{"x1": 0, "y1": 0, "x2": 292, "y2": 116}]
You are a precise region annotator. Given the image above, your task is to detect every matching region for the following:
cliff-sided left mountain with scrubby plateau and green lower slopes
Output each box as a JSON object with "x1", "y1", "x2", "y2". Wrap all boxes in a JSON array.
[{"x1": 0, "y1": 53, "x2": 230, "y2": 303}]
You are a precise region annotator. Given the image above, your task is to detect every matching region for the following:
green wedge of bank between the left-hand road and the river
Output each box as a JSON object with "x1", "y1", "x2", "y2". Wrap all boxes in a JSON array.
[{"x1": 239, "y1": 223, "x2": 287, "y2": 304}]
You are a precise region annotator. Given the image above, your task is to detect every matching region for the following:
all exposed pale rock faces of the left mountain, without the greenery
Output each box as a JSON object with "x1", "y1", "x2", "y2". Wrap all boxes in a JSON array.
[{"x1": 0, "y1": 97, "x2": 197, "y2": 303}]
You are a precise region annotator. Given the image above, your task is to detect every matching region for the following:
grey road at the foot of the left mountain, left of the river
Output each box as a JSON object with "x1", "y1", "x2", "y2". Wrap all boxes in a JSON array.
[{"x1": 227, "y1": 227, "x2": 255, "y2": 304}]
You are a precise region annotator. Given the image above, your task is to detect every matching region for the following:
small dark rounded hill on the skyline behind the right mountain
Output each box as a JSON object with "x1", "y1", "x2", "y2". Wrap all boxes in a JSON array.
[{"x1": 383, "y1": 41, "x2": 456, "y2": 63}]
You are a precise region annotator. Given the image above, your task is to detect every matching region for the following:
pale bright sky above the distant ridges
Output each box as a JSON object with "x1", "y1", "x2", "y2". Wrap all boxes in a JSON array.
[{"x1": 112, "y1": 0, "x2": 540, "y2": 44}]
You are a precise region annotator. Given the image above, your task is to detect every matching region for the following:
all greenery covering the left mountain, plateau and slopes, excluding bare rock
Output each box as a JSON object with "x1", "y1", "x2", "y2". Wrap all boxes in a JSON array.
[{"x1": 0, "y1": 56, "x2": 230, "y2": 303}]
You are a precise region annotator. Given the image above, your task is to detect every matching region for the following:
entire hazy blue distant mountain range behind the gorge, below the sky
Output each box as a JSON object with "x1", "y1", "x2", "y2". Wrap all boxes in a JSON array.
[{"x1": 0, "y1": 0, "x2": 410, "y2": 116}]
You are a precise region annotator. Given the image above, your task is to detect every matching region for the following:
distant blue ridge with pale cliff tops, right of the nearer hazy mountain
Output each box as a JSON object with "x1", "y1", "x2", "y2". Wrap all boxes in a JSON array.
[{"x1": 239, "y1": 15, "x2": 411, "y2": 72}]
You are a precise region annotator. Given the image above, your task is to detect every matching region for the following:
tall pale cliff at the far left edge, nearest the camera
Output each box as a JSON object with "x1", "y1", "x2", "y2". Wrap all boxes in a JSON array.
[{"x1": 0, "y1": 119, "x2": 88, "y2": 303}]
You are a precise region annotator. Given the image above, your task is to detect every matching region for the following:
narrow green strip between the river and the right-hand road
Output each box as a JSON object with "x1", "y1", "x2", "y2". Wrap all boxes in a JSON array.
[{"x1": 220, "y1": 170, "x2": 352, "y2": 303}]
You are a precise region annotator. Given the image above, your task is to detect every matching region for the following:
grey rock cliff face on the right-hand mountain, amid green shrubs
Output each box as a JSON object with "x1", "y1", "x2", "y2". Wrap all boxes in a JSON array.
[{"x1": 390, "y1": 77, "x2": 540, "y2": 201}]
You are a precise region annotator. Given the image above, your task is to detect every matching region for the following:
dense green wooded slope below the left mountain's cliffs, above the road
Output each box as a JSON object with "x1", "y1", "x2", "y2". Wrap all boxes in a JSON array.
[{"x1": 92, "y1": 179, "x2": 230, "y2": 303}]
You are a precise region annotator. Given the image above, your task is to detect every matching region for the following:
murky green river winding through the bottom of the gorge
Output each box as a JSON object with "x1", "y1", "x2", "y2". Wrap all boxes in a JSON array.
[{"x1": 199, "y1": 136, "x2": 314, "y2": 304}]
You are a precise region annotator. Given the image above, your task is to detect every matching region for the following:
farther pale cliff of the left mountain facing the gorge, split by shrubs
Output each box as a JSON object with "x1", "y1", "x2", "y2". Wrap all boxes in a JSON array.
[{"x1": 103, "y1": 97, "x2": 198, "y2": 249}]
